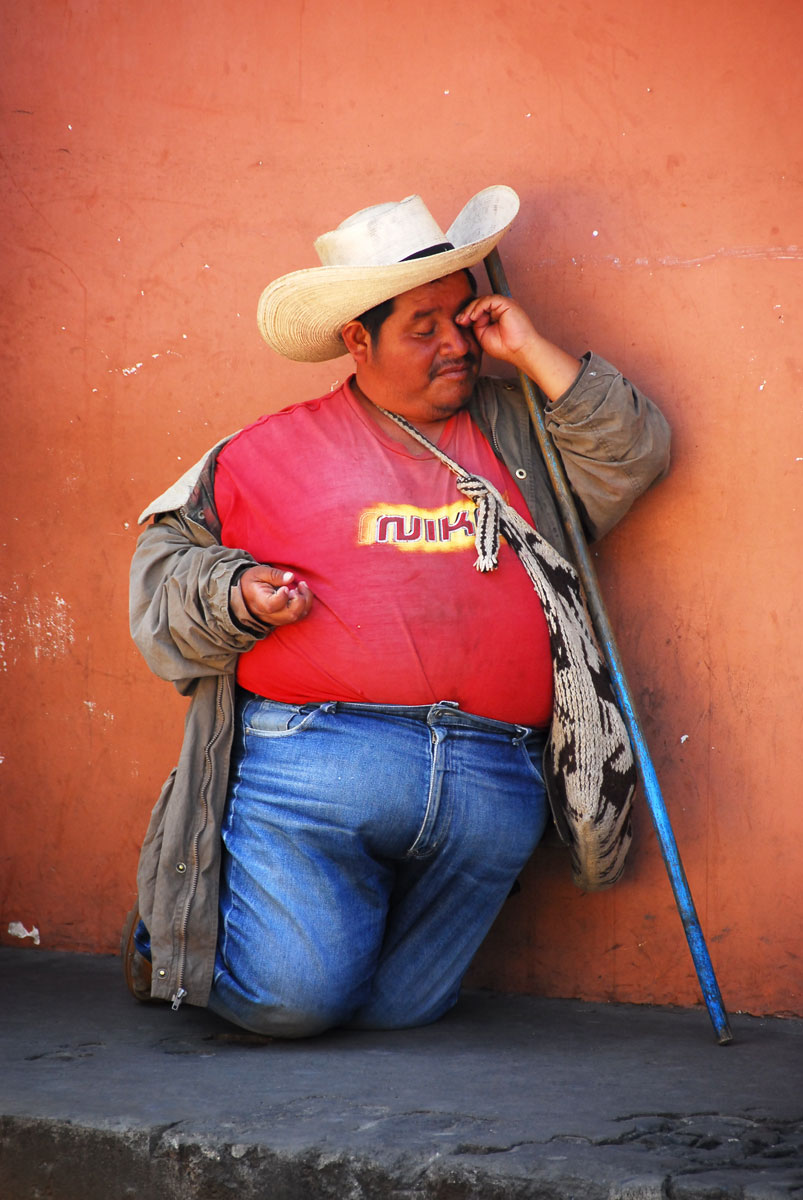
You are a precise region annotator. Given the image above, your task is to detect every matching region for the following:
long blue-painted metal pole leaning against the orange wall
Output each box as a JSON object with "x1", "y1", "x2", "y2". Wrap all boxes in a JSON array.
[{"x1": 485, "y1": 250, "x2": 732, "y2": 1045}]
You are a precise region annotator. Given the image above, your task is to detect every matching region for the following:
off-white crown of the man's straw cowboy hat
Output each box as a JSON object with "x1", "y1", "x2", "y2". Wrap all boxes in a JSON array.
[{"x1": 314, "y1": 196, "x2": 447, "y2": 266}]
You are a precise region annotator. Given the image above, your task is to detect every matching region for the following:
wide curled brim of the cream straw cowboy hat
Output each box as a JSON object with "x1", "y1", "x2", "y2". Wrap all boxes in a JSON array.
[{"x1": 257, "y1": 185, "x2": 519, "y2": 362}]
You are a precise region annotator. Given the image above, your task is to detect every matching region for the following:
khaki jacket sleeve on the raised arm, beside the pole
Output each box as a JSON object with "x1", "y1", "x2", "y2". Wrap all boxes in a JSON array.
[{"x1": 545, "y1": 354, "x2": 670, "y2": 540}]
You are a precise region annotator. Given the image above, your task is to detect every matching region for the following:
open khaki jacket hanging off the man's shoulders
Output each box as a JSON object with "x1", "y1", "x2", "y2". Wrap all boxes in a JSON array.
[{"x1": 131, "y1": 354, "x2": 670, "y2": 1007}]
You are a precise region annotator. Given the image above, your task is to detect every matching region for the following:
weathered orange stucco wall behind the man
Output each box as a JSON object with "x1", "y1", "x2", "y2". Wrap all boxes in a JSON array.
[{"x1": 0, "y1": 0, "x2": 803, "y2": 1013}]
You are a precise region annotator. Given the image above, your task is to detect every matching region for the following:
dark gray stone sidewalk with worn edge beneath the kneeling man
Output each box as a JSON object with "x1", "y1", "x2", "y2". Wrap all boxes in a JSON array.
[{"x1": 0, "y1": 949, "x2": 803, "y2": 1200}]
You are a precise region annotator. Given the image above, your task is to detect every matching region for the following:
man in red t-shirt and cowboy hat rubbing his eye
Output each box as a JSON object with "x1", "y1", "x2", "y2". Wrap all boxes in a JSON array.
[{"x1": 124, "y1": 187, "x2": 669, "y2": 1037}]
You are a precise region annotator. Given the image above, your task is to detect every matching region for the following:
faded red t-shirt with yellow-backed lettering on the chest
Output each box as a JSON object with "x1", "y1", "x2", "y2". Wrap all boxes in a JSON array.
[{"x1": 215, "y1": 384, "x2": 552, "y2": 725}]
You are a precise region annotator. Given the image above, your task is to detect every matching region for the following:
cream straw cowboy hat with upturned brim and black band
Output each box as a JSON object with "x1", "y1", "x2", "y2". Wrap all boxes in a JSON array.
[{"x1": 257, "y1": 185, "x2": 519, "y2": 362}]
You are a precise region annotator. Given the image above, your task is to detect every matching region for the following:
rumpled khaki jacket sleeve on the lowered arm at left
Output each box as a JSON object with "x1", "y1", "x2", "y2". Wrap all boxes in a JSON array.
[{"x1": 130, "y1": 512, "x2": 269, "y2": 695}]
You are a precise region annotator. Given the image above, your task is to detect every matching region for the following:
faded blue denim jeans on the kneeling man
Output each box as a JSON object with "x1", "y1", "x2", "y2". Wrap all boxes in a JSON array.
[{"x1": 209, "y1": 692, "x2": 547, "y2": 1037}]
